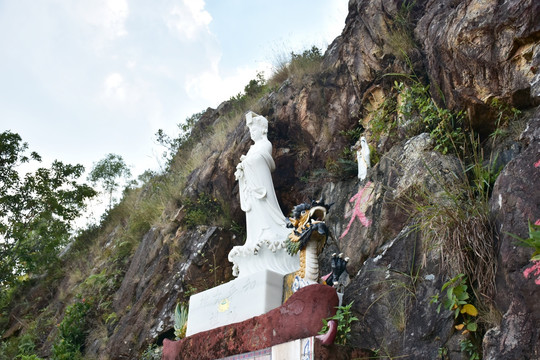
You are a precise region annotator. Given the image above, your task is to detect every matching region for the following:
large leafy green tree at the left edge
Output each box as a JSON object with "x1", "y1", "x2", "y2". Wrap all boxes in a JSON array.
[{"x1": 0, "y1": 131, "x2": 96, "y2": 287}]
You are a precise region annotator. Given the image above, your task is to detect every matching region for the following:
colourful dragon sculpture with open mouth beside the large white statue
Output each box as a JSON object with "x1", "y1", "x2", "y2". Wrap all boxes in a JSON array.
[{"x1": 285, "y1": 199, "x2": 332, "y2": 288}]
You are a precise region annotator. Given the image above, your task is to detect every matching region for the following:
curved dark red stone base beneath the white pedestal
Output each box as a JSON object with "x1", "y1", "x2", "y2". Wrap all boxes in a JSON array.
[{"x1": 162, "y1": 284, "x2": 338, "y2": 360}]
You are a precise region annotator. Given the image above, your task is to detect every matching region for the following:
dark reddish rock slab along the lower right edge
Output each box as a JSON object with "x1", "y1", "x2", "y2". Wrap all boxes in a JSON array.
[{"x1": 484, "y1": 110, "x2": 540, "y2": 359}]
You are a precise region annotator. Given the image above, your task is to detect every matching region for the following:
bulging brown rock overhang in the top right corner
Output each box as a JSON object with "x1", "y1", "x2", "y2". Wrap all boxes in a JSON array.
[{"x1": 415, "y1": 0, "x2": 540, "y2": 126}]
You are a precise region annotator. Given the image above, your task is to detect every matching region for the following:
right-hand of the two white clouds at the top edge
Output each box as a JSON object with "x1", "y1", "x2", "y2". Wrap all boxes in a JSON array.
[{"x1": 165, "y1": 0, "x2": 212, "y2": 41}]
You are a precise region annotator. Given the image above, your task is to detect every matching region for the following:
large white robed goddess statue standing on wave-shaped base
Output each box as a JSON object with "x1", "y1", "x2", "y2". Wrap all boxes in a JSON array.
[{"x1": 229, "y1": 111, "x2": 299, "y2": 276}]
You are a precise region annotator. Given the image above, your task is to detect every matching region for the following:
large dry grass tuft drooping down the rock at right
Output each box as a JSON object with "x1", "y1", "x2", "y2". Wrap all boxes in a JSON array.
[{"x1": 402, "y1": 176, "x2": 497, "y2": 299}]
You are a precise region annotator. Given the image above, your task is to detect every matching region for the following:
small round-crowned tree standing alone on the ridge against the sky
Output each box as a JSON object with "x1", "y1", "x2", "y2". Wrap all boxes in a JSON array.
[{"x1": 88, "y1": 154, "x2": 131, "y2": 210}]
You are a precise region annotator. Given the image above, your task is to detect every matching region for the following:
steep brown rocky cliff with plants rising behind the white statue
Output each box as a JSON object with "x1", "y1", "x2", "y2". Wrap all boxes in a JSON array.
[{"x1": 3, "y1": 0, "x2": 540, "y2": 359}]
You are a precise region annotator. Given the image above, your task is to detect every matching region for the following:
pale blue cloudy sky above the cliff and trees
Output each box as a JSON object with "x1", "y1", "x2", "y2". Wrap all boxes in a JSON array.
[{"x1": 0, "y1": 0, "x2": 348, "y2": 176}]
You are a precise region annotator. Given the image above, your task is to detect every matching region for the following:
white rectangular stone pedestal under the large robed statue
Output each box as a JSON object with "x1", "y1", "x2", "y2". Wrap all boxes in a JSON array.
[{"x1": 186, "y1": 270, "x2": 283, "y2": 336}]
